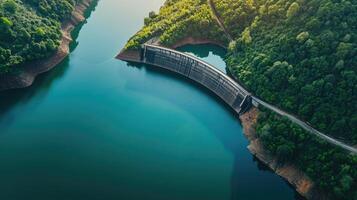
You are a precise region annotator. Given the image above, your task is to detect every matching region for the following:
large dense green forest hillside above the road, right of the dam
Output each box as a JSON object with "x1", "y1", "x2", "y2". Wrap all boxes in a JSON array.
[{"x1": 216, "y1": 0, "x2": 357, "y2": 144}]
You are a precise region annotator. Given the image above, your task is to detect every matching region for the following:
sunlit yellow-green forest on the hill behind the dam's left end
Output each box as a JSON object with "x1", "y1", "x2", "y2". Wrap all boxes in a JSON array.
[{"x1": 126, "y1": 0, "x2": 228, "y2": 49}]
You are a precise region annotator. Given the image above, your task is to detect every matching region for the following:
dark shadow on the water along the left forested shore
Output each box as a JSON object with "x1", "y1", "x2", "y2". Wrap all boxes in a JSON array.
[{"x1": 0, "y1": 0, "x2": 98, "y2": 128}]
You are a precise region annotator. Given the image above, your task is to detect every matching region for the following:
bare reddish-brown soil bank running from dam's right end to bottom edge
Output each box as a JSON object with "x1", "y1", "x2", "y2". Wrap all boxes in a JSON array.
[{"x1": 240, "y1": 108, "x2": 327, "y2": 199}]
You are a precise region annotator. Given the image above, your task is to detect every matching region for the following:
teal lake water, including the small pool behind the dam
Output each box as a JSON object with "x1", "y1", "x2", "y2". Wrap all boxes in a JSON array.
[{"x1": 0, "y1": 0, "x2": 298, "y2": 200}]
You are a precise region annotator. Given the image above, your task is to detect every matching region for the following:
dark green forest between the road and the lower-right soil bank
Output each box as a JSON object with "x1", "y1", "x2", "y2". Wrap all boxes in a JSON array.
[{"x1": 256, "y1": 110, "x2": 357, "y2": 200}]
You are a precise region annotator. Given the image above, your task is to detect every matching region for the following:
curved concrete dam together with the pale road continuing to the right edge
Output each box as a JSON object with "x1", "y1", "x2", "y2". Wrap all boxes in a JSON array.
[{"x1": 117, "y1": 43, "x2": 357, "y2": 154}]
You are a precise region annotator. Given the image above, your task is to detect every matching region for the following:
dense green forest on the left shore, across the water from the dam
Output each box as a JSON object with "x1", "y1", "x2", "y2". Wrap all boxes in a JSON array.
[{"x1": 0, "y1": 0, "x2": 78, "y2": 73}]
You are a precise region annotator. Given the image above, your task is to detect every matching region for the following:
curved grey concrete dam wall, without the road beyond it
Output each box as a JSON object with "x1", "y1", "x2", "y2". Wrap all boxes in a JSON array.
[{"x1": 118, "y1": 44, "x2": 252, "y2": 114}]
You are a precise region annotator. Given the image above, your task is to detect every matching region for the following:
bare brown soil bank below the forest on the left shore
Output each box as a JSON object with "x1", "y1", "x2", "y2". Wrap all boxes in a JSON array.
[{"x1": 0, "y1": 0, "x2": 95, "y2": 91}]
